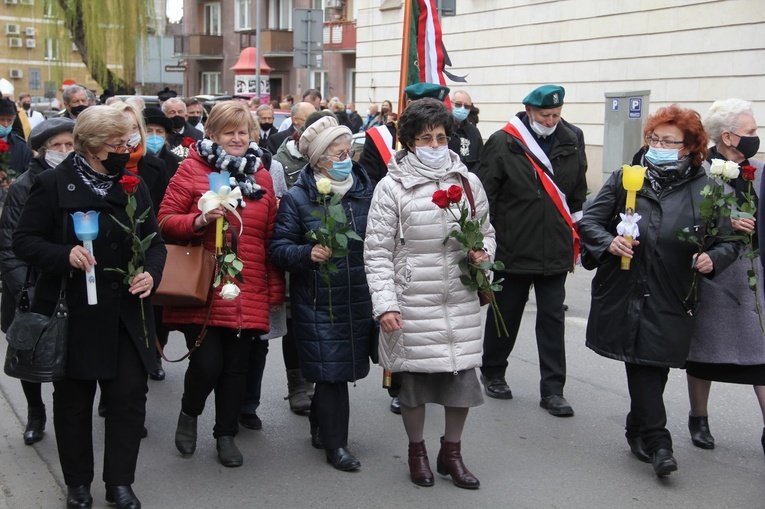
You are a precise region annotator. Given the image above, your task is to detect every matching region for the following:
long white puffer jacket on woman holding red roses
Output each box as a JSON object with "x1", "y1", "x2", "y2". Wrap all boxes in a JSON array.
[{"x1": 364, "y1": 151, "x2": 496, "y2": 373}]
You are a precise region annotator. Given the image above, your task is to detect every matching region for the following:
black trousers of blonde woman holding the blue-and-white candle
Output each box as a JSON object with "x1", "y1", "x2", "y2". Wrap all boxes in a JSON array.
[{"x1": 53, "y1": 327, "x2": 148, "y2": 486}]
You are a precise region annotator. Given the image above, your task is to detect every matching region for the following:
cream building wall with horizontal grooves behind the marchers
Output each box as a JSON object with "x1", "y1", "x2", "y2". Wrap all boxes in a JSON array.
[{"x1": 356, "y1": 0, "x2": 765, "y2": 188}]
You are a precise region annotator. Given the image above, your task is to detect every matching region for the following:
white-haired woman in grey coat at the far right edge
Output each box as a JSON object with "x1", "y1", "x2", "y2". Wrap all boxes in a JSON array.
[{"x1": 686, "y1": 99, "x2": 765, "y2": 450}]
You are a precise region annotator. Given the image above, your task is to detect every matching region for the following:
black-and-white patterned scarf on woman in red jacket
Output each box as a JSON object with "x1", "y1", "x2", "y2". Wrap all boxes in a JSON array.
[{"x1": 196, "y1": 138, "x2": 266, "y2": 202}]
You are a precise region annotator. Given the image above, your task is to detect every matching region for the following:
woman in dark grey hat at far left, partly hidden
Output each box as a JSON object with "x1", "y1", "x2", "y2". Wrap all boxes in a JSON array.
[{"x1": 0, "y1": 117, "x2": 74, "y2": 445}]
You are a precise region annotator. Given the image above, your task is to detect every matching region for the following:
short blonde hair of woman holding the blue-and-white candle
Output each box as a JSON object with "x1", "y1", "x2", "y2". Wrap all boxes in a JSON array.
[{"x1": 74, "y1": 106, "x2": 133, "y2": 157}]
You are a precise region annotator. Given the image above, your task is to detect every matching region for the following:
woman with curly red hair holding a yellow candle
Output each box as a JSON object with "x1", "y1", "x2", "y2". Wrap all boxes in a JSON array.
[{"x1": 579, "y1": 105, "x2": 737, "y2": 477}]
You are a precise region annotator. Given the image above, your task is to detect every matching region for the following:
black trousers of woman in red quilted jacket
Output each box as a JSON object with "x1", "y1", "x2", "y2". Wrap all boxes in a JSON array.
[{"x1": 181, "y1": 325, "x2": 251, "y2": 438}]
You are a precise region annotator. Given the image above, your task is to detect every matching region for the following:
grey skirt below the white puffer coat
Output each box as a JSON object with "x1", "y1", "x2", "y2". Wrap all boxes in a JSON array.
[{"x1": 398, "y1": 369, "x2": 483, "y2": 408}]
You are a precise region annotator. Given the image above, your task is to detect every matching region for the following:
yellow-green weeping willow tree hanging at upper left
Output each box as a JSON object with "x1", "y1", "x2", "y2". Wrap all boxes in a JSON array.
[{"x1": 56, "y1": 0, "x2": 154, "y2": 94}]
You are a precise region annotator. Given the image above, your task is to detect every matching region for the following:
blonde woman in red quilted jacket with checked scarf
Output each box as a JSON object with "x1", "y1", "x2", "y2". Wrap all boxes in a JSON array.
[{"x1": 158, "y1": 101, "x2": 284, "y2": 467}]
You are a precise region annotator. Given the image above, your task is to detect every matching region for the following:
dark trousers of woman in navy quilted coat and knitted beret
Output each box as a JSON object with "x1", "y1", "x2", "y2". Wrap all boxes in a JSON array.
[{"x1": 308, "y1": 382, "x2": 351, "y2": 449}]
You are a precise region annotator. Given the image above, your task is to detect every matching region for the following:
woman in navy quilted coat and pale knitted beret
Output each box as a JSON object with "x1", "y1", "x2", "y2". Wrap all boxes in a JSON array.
[{"x1": 270, "y1": 116, "x2": 376, "y2": 471}]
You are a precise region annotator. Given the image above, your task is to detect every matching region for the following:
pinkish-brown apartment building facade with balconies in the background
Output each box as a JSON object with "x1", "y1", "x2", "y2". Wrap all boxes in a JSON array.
[{"x1": 175, "y1": 0, "x2": 358, "y2": 101}]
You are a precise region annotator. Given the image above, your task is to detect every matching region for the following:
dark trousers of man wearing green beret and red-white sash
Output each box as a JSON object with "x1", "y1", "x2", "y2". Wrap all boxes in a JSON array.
[{"x1": 481, "y1": 273, "x2": 568, "y2": 397}]
